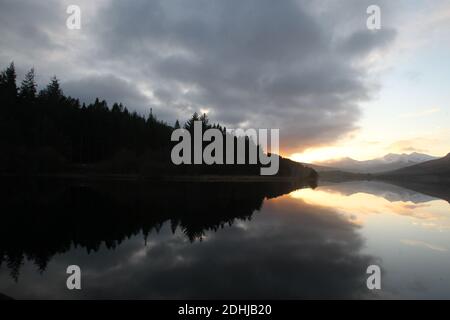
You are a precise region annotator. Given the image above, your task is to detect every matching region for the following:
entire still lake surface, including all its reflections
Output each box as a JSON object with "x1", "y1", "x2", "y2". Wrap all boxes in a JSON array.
[{"x1": 0, "y1": 182, "x2": 450, "y2": 299}]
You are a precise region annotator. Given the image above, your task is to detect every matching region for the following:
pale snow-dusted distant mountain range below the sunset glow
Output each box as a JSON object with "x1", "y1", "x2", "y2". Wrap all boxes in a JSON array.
[{"x1": 315, "y1": 152, "x2": 437, "y2": 173}]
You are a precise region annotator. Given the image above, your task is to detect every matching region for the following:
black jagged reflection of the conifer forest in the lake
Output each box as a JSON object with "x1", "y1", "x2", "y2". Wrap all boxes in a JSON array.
[{"x1": 0, "y1": 181, "x2": 312, "y2": 279}]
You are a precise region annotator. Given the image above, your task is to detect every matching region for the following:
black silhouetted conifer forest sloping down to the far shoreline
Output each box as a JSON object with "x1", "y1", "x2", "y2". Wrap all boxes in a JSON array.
[{"x1": 0, "y1": 63, "x2": 315, "y2": 180}]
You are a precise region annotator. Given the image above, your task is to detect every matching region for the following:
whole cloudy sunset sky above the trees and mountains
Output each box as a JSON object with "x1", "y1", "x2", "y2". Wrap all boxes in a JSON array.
[{"x1": 0, "y1": 0, "x2": 450, "y2": 161}]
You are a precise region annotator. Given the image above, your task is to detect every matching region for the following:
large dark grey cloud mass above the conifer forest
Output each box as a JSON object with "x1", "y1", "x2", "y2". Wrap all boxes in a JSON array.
[{"x1": 0, "y1": 0, "x2": 395, "y2": 151}]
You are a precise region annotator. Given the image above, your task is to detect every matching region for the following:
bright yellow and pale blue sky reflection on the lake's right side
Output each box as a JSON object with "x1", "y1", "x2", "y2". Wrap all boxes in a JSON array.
[{"x1": 290, "y1": 182, "x2": 450, "y2": 299}]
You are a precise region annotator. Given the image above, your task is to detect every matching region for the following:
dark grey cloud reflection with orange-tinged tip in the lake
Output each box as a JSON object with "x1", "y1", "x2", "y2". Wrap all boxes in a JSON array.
[{"x1": 0, "y1": 197, "x2": 374, "y2": 299}]
